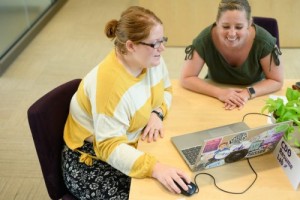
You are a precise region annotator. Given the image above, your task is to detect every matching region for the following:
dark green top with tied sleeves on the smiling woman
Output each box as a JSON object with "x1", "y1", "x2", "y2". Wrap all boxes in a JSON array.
[{"x1": 185, "y1": 23, "x2": 281, "y2": 85}]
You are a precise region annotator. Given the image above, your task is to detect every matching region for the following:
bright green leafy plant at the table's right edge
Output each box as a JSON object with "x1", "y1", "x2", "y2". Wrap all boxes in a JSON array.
[{"x1": 262, "y1": 88, "x2": 300, "y2": 149}]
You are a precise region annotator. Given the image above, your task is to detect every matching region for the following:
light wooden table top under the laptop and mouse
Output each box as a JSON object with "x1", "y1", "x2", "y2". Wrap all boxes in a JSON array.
[{"x1": 130, "y1": 80, "x2": 300, "y2": 200}]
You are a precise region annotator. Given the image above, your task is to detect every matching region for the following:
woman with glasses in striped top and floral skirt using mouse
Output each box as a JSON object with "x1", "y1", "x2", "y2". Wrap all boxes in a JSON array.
[{"x1": 62, "y1": 6, "x2": 190, "y2": 199}]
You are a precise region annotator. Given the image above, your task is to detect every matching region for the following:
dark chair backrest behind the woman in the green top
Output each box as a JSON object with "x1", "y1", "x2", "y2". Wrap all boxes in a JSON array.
[{"x1": 253, "y1": 16, "x2": 280, "y2": 48}]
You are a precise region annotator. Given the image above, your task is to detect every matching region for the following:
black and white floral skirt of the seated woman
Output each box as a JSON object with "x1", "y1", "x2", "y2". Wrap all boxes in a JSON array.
[{"x1": 62, "y1": 142, "x2": 131, "y2": 200}]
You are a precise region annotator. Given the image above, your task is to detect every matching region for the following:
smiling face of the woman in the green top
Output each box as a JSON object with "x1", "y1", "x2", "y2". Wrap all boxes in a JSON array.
[{"x1": 216, "y1": 10, "x2": 251, "y2": 48}]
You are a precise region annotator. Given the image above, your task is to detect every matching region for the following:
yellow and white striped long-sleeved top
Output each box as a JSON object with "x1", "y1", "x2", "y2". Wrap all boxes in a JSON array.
[{"x1": 64, "y1": 50, "x2": 172, "y2": 178}]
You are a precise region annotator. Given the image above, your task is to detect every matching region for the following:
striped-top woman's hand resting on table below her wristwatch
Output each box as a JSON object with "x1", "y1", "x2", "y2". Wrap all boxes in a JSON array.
[{"x1": 142, "y1": 113, "x2": 164, "y2": 142}]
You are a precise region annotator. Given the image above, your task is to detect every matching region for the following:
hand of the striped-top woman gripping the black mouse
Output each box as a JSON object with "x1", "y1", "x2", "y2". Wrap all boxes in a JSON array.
[{"x1": 152, "y1": 163, "x2": 191, "y2": 194}]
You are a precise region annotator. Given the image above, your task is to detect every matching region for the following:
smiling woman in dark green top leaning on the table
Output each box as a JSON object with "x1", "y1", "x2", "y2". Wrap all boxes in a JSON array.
[{"x1": 181, "y1": 0, "x2": 283, "y2": 110}]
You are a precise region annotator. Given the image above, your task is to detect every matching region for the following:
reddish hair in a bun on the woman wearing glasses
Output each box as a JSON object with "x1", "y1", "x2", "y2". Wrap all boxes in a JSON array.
[{"x1": 104, "y1": 6, "x2": 162, "y2": 54}]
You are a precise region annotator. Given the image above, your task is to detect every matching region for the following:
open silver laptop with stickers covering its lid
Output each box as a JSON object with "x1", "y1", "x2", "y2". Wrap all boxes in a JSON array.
[{"x1": 171, "y1": 121, "x2": 291, "y2": 171}]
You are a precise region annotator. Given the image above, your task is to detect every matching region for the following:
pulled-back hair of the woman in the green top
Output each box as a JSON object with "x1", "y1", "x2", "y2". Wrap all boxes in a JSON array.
[{"x1": 217, "y1": 0, "x2": 251, "y2": 21}]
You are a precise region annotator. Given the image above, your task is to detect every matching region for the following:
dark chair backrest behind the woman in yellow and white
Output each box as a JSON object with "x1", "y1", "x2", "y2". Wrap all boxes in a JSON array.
[{"x1": 27, "y1": 79, "x2": 81, "y2": 199}]
